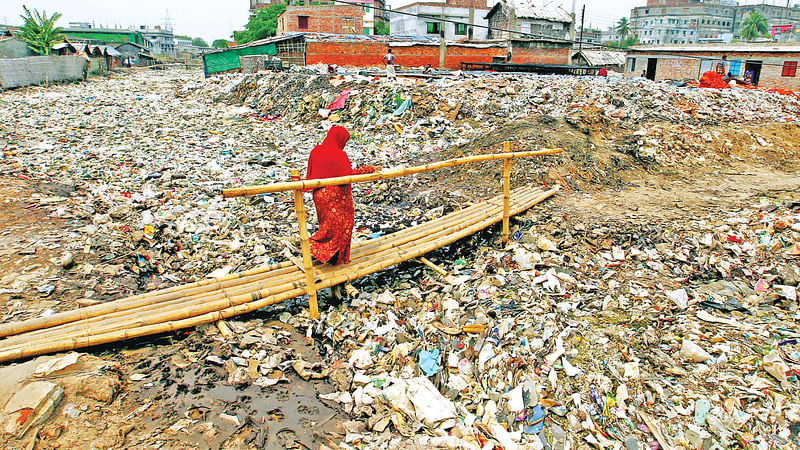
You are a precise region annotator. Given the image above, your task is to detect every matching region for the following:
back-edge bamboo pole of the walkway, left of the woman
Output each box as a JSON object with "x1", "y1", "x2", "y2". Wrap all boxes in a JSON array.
[{"x1": 0, "y1": 261, "x2": 292, "y2": 337}]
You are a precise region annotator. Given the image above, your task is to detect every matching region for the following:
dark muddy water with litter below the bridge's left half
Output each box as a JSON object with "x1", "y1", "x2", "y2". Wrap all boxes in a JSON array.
[{"x1": 123, "y1": 321, "x2": 347, "y2": 449}]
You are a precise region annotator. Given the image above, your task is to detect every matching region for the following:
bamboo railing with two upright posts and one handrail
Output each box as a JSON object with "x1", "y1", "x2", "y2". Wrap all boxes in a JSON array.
[{"x1": 222, "y1": 146, "x2": 563, "y2": 319}]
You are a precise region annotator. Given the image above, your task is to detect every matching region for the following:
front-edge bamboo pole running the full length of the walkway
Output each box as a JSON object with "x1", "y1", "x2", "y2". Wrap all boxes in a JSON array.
[{"x1": 0, "y1": 189, "x2": 557, "y2": 362}]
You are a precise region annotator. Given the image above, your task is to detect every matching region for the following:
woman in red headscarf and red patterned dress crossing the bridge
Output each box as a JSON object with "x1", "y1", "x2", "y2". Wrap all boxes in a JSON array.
[{"x1": 306, "y1": 127, "x2": 380, "y2": 264}]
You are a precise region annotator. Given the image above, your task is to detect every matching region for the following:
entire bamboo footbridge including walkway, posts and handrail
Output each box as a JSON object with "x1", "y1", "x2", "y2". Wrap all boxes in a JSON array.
[{"x1": 0, "y1": 143, "x2": 562, "y2": 362}]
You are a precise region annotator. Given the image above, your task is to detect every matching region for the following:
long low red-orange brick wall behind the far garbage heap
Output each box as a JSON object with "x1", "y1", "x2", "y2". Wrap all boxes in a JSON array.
[{"x1": 306, "y1": 42, "x2": 506, "y2": 69}]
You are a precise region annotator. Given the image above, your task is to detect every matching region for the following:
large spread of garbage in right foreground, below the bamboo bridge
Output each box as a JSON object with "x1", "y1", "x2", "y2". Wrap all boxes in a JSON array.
[{"x1": 258, "y1": 201, "x2": 800, "y2": 449}]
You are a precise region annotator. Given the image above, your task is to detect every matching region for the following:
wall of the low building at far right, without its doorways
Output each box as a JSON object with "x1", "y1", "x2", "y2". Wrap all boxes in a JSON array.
[{"x1": 625, "y1": 51, "x2": 800, "y2": 89}]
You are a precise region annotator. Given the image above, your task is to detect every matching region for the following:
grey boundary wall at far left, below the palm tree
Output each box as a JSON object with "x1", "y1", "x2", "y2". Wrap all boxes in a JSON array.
[{"x1": 0, "y1": 56, "x2": 86, "y2": 89}]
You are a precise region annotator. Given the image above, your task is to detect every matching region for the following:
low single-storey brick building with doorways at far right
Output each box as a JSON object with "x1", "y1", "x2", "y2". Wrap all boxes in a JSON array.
[{"x1": 625, "y1": 44, "x2": 800, "y2": 89}]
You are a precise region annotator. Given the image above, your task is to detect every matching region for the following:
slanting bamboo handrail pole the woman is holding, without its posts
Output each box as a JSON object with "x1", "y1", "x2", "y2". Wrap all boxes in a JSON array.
[{"x1": 222, "y1": 148, "x2": 563, "y2": 198}]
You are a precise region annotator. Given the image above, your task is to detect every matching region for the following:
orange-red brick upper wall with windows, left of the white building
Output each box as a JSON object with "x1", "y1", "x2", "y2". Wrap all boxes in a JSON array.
[{"x1": 278, "y1": 5, "x2": 364, "y2": 34}]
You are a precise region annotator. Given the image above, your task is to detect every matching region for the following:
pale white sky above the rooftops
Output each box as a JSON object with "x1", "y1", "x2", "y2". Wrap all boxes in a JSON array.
[{"x1": 0, "y1": 0, "x2": 784, "y2": 43}]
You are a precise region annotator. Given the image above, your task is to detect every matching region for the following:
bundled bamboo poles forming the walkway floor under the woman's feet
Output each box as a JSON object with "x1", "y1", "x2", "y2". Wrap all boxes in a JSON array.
[{"x1": 0, "y1": 182, "x2": 556, "y2": 362}]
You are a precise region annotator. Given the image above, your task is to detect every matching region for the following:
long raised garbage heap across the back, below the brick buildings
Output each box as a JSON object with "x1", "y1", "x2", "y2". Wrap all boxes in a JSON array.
[{"x1": 200, "y1": 72, "x2": 800, "y2": 128}]
